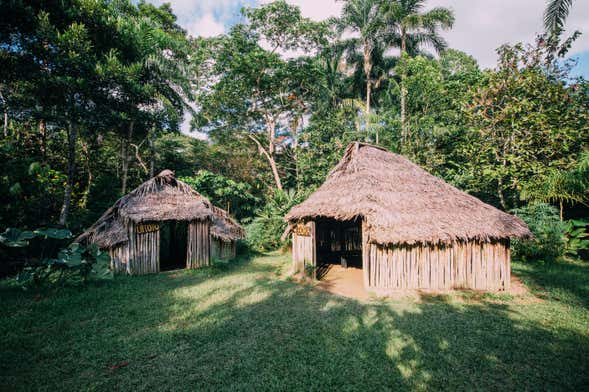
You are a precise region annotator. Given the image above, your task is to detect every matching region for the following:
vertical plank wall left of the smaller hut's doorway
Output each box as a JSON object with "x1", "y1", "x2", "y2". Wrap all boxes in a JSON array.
[{"x1": 127, "y1": 222, "x2": 160, "y2": 275}]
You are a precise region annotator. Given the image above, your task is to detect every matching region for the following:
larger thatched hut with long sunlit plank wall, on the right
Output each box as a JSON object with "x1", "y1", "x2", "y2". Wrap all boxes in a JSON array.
[{"x1": 286, "y1": 143, "x2": 531, "y2": 292}]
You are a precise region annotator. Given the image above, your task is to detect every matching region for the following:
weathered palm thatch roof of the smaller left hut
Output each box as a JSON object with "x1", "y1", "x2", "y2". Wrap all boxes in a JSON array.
[{"x1": 77, "y1": 170, "x2": 243, "y2": 248}]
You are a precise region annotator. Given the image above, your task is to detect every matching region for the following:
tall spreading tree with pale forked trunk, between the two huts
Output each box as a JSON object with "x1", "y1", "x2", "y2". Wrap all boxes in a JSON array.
[{"x1": 195, "y1": 0, "x2": 326, "y2": 189}]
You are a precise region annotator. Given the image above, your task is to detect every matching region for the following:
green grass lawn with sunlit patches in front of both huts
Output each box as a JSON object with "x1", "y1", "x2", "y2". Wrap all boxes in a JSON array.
[{"x1": 0, "y1": 254, "x2": 589, "y2": 391}]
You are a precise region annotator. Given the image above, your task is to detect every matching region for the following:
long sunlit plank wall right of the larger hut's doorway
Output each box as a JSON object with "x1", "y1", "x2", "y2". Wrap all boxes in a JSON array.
[{"x1": 364, "y1": 240, "x2": 511, "y2": 291}]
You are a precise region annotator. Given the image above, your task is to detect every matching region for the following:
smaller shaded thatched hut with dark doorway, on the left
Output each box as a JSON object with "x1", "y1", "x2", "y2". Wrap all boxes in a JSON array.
[{"x1": 78, "y1": 170, "x2": 244, "y2": 275}]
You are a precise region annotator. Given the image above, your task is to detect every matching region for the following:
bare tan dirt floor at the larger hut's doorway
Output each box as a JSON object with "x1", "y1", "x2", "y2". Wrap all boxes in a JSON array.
[{"x1": 317, "y1": 264, "x2": 370, "y2": 300}]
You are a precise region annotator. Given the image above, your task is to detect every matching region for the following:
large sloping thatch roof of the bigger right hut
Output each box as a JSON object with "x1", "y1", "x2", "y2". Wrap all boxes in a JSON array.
[{"x1": 286, "y1": 143, "x2": 532, "y2": 244}]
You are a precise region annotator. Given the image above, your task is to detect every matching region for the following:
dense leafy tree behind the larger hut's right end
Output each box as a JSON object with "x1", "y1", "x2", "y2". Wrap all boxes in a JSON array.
[{"x1": 461, "y1": 36, "x2": 589, "y2": 209}]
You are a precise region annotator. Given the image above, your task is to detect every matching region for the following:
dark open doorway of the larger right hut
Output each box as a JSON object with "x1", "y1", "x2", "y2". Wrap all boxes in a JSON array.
[{"x1": 316, "y1": 219, "x2": 362, "y2": 279}]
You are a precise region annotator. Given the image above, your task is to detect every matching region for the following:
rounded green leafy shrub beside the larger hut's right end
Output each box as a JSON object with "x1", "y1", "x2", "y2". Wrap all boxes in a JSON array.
[{"x1": 512, "y1": 203, "x2": 566, "y2": 262}]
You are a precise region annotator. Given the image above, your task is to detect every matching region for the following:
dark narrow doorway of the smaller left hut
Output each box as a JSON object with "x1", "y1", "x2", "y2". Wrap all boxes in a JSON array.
[{"x1": 160, "y1": 221, "x2": 188, "y2": 271}]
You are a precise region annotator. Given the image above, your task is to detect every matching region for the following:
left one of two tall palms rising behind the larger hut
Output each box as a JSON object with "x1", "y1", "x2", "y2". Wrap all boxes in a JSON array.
[{"x1": 336, "y1": 0, "x2": 386, "y2": 120}]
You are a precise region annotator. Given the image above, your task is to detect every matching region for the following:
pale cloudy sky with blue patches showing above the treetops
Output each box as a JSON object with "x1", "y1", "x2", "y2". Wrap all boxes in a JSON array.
[{"x1": 150, "y1": 0, "x2": 589, "y2": 133}]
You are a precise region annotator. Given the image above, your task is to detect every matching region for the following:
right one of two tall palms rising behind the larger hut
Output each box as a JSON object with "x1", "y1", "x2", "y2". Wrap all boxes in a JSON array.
[{"x1": 385, "y1": 0, "x2": 454, "y2": 144}]
